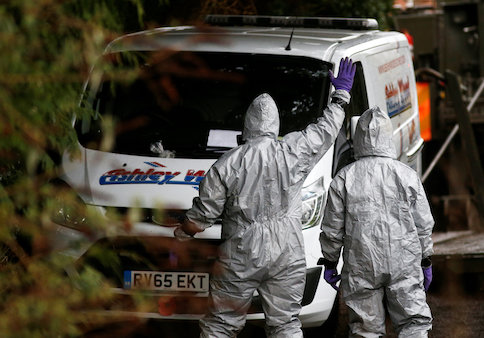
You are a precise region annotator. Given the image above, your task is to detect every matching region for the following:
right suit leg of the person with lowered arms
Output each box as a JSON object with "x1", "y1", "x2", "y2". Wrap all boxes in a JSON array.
[{"x1": 386, "y1": 275, "x2": 432, "y2": 338}]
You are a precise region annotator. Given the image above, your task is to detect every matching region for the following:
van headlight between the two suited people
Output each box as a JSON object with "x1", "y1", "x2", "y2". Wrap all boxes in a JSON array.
[{"x1": 301, "y1": 177, "x2": 327, "y2": 229}]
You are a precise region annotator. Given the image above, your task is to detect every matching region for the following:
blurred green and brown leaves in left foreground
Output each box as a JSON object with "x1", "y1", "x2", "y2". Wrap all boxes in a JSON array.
[{"x1": 0, "y1": 0, "x2": 159, "y2": 337}]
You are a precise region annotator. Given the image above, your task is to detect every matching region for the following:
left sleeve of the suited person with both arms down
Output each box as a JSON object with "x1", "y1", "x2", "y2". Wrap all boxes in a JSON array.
[{"x1": 319, "y1": 176, "x2": 345, "y2": 262}]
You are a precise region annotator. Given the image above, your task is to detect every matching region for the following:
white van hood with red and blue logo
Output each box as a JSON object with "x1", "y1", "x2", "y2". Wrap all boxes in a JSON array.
[{"x1": 63, "y1": 149, "x2": 215, "y2": 210}]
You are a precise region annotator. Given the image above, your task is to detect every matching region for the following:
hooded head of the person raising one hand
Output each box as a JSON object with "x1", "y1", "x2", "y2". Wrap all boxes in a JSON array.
[{"x1": 242, "y1": 93, "x2": 279, "y2": 140}]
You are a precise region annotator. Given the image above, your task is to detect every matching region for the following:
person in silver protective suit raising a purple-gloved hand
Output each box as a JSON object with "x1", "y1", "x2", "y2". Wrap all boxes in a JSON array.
[{"x1": 175, "y1": 59, "x2": 355, "y2": 338}]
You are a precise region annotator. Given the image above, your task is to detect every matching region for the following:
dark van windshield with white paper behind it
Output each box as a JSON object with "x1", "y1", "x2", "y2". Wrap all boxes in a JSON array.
[{"x1": 76, "y1": 52, "x2": 331, "y2": 158}]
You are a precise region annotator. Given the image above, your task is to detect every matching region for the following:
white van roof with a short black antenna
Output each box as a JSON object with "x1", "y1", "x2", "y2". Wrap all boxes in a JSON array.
[{"x1": 106, "y1": 17, "x2": 405, "y2": 61}]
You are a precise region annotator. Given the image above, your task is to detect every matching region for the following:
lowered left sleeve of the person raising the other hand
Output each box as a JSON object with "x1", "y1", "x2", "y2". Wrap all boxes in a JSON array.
[{"x1": 186, "y1": 165, "x2": 227, "y2": 229}]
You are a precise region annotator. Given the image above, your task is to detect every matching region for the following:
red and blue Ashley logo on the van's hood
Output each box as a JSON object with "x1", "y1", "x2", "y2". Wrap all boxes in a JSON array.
[{"x1": 99, "y1": 162, "x2": 205, "y2": 190}]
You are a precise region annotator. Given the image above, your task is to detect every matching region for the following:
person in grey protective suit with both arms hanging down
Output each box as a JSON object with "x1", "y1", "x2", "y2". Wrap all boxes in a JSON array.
[{"x1": 320, "y1": 107, "x2": 434, "y2": 337}]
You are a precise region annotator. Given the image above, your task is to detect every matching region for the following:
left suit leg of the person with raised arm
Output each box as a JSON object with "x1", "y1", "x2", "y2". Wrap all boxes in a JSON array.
[{"x1": 200, "y1": 266, "x2": 257, "y2": 338}]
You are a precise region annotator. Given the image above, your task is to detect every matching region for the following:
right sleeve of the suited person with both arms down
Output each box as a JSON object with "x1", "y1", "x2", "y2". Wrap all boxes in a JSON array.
[{"x1": 411, "y1": 178, "x2": 434, "y2": 258}]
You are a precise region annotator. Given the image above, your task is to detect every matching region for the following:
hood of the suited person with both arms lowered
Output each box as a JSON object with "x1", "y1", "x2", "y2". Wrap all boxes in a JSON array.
[{"x1": 353, "y1": 107, "x2": 396, "y2": 159}]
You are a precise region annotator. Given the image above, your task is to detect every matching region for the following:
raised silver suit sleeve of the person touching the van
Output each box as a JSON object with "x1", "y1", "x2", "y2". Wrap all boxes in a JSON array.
[{"x1": 283, "y1": 90, "x2": 350, "y2": 171}]
